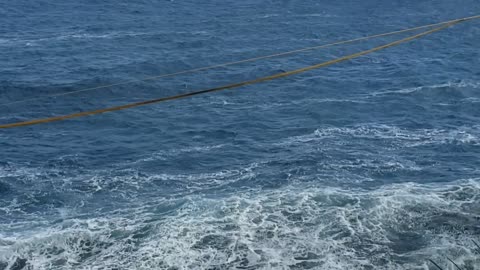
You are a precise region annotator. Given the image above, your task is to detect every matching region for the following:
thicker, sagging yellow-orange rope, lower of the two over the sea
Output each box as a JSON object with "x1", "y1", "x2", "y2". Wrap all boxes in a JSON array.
[{"x1": 0, "y1": 15, "x2": 480, "y2": 128}]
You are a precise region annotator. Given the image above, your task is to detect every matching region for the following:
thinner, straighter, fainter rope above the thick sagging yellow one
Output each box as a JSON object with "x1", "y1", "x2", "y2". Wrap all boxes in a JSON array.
[{"x1": 0, "y1": 15, "x2": 480, "y2": 106}]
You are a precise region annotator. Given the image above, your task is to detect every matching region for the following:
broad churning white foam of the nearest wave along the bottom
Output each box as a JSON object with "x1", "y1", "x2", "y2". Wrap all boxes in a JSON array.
[{"x1": 0, "y1": 179, "x2": 480, "y2": 269}]
